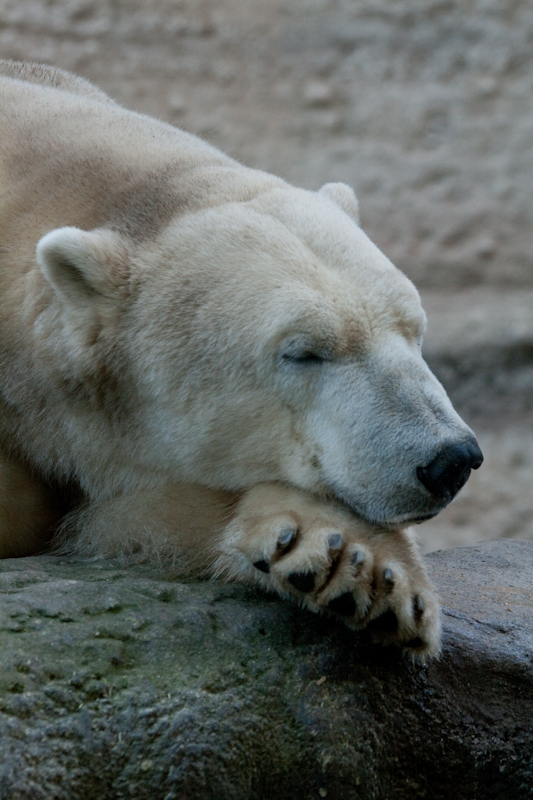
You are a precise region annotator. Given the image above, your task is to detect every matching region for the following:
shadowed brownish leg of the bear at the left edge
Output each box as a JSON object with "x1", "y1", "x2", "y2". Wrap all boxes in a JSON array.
[{"x1": 0, "y1": 451, "x2": 58, "y2": 558}]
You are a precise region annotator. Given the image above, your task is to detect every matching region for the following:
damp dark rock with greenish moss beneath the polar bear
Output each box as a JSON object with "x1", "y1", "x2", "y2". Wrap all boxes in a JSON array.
[{"x1": 0, "y1": 541, "x2": 533, "y2": 800}]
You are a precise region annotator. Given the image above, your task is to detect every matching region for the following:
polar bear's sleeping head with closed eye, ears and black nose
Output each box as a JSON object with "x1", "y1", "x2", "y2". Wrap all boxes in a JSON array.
[{"x1": 37, "y1": 177, "x2": 482, "y2": 525}]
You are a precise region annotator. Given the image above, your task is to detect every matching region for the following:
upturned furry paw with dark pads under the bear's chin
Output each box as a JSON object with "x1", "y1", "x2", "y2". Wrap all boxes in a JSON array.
[{"x1": 215, "y1": 484, "x2": 440, "y2": 659}]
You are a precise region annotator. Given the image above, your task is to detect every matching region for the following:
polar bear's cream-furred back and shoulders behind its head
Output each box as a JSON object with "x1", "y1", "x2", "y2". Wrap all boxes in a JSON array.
[{"x1": 0, "y1": 61, "x2": 282, "y2": 278}]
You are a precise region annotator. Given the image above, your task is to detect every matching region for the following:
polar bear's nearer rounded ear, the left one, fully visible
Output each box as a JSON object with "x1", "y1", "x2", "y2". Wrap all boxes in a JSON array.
[{"x1": 37, "y1": 228, "x2": 126, "y2": 305}]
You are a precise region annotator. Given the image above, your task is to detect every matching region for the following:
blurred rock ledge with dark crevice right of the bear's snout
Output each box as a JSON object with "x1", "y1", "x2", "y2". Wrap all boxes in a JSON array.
[{"x1": 420, "y1": 287, "x2": 533, "y2": 551}]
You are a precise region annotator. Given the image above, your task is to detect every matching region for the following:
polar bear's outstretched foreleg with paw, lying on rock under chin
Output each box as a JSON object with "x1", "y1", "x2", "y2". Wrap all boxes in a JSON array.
[{"x1": 53, "y1": 483, "x2": 440, "y2": 658}]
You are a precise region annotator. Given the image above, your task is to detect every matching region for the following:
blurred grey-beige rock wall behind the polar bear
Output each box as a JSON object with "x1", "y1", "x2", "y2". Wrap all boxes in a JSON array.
[{"x1": 0, "y1": 0, "x2": 533, "y2": 551}]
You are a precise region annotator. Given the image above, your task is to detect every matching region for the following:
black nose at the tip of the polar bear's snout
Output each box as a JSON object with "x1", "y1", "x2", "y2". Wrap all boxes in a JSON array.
[{"x1": 416, "y1": 439, "x2": 483, "y2": 502}]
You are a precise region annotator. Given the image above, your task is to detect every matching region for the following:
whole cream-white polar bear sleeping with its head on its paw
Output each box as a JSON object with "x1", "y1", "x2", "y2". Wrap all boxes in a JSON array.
[{"x1": 0, "y1": 61, "x2": 482, "y2": 656}]
